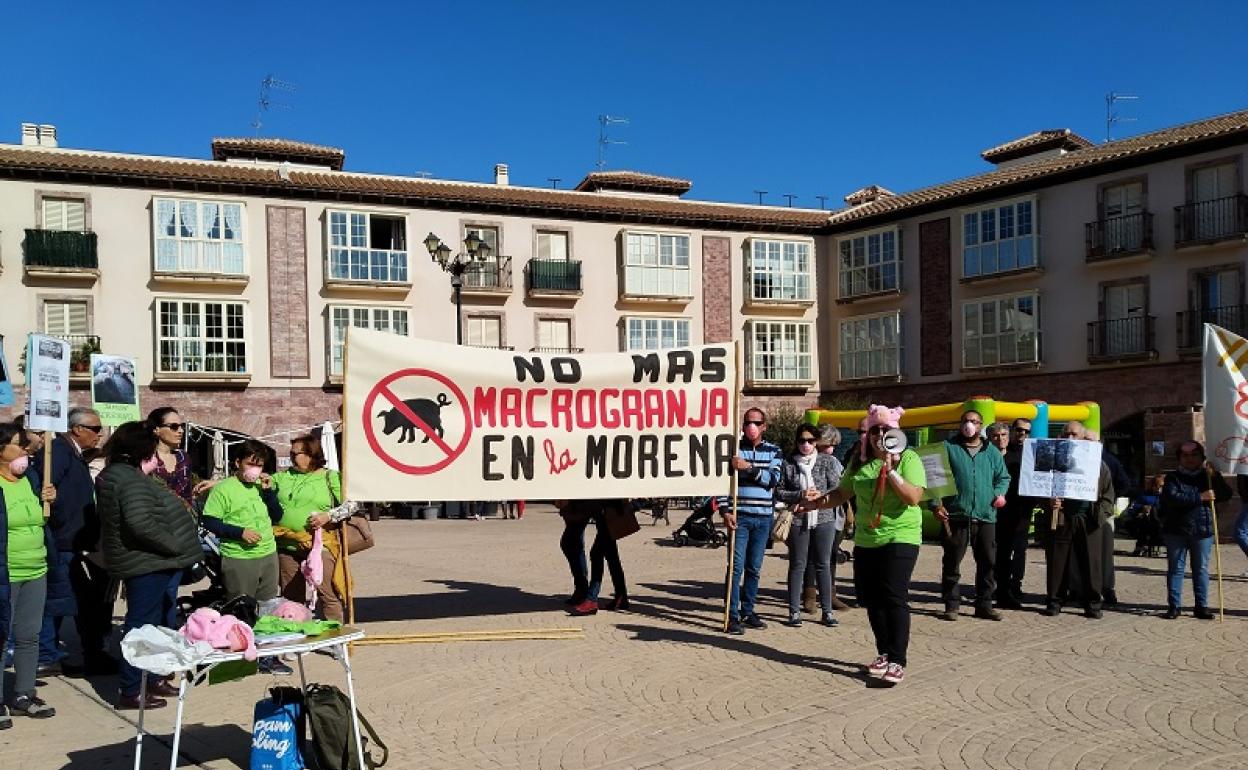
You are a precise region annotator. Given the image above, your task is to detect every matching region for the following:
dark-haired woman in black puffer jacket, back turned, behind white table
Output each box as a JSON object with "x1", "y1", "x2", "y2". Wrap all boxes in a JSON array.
[{"x1": 96, "y1": 422, "x2": 201, "y2": 709}]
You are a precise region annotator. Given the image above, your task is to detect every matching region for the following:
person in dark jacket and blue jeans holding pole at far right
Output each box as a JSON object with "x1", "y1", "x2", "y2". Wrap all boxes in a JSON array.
[{"x1": 1161, "y1": 441, "x2": 1232, "y2": 620}]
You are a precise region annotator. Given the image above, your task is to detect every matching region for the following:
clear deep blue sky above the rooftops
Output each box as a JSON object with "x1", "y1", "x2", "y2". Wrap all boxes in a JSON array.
[{"x1": 0, "y1": 0, "x2": 1248, "y2": 207}]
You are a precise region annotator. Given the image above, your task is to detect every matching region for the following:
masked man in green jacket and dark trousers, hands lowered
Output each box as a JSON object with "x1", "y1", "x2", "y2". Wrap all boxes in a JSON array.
[{"x1": 931, "y1": 409, "x2": 1010, "y2": 620}]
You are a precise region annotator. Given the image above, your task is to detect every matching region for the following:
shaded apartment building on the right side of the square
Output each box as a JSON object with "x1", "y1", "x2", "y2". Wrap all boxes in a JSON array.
[{"x1": 820, "y1": 111, "x2": 1248, "y2": 470}]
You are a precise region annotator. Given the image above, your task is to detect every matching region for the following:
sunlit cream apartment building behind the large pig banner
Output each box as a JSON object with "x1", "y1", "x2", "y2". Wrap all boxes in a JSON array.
[{"x1": 0, "y1": 129, "x2": 831, "y2": 434}]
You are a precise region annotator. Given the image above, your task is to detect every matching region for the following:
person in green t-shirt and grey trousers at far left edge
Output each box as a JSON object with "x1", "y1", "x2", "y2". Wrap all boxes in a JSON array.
[{"x1": 0, "y1": 423, "x2": 56, "y2": 729}]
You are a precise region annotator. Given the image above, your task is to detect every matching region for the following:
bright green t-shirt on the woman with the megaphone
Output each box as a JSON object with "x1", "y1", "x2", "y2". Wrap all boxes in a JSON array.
[{"x1": 841, "y1": 451, "x2": 927, "y2": 548}]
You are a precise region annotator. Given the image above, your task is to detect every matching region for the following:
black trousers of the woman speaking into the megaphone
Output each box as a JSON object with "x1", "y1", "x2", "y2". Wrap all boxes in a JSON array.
[{"x1": 854, "y1": 543, "x2": 919, "y2": 665}]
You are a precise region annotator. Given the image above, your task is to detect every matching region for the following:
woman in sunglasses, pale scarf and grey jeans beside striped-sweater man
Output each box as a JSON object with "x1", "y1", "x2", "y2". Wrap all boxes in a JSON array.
[{"x1": 776, "y1": 424, "x2": 841, "y2": 628}]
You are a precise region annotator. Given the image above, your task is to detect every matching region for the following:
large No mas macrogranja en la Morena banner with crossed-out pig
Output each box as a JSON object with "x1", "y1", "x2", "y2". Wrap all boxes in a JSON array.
[{"x1": 343, "y1": 328, "x2": 738, "y2": 502}]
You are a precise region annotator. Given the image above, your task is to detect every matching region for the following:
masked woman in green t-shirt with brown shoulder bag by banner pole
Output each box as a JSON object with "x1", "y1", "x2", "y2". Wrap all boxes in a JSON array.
[{"x1": 273, "y1": 434, "x2": 346, "y2": 621}]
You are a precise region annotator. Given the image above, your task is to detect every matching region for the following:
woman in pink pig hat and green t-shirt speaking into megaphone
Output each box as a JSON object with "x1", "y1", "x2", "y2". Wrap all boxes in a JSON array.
[{"x1": 801, "y1": 404, "x2": 927, "y2": 685}]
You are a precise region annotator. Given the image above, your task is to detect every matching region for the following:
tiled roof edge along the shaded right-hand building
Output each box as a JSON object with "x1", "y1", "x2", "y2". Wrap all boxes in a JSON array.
[{"x1": 830, "y1": 110, "x2": 1248, "y2": 232}]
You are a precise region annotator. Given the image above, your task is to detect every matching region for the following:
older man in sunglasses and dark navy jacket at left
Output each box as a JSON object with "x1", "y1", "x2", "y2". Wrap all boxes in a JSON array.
[{"x1": 39, "y1": 407, "x2": 117, "y2": 675}]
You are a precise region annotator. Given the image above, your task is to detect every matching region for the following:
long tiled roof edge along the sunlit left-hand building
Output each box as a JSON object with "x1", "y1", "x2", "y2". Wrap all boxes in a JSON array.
[{"x1": 0, "y1": 145, "x2": 829, "y2": 233}]
